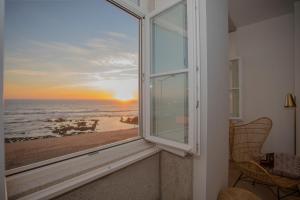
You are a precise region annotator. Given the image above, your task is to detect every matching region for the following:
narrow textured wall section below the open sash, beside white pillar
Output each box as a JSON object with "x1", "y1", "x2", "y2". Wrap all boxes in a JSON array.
[{"x1": 160, "y1": 151, "x2": 193, "y2": 200}]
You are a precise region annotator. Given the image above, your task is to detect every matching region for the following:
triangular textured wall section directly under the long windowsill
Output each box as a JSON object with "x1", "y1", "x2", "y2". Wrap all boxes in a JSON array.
[{"x1": 56, "y1": 154, "x2": 159, "y2": 200}]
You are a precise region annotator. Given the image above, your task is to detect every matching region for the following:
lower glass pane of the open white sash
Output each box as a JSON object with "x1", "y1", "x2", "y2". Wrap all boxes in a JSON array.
[{"x1": 150, "y1": 73, "x2": 188, "y2": 143}]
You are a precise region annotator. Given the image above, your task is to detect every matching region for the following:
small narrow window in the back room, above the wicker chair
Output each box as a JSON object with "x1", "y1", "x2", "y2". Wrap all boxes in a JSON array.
[{"x1": 229, "y1": 59, "x2": 241, "y2": 119}]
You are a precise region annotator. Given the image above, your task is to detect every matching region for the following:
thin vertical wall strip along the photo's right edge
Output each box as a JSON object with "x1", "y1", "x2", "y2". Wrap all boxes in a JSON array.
[{"x1": 294, "y1": 1, "x2": 300, "y2": 155}]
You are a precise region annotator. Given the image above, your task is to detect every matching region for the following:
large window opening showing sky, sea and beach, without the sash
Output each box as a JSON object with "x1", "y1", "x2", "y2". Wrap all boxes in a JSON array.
[{"x1": 4, "y1": 0, "x2": 140, "y2": 170}]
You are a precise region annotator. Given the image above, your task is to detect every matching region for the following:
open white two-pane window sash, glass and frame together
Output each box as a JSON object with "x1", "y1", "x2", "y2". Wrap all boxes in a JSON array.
[{"x1": 143, "y1": 0, "x2": 197, "y2": 153}]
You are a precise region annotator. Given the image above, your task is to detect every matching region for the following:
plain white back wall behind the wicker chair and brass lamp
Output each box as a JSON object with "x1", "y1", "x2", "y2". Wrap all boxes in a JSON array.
[{"x1": 229, "y1": 14, "x2": 294, "y2": 153}]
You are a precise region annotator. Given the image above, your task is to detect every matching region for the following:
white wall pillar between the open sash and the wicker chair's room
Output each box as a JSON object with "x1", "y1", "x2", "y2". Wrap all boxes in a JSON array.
[{"x1": 193, "y1": 0, "x2": 229, "y2": 200}]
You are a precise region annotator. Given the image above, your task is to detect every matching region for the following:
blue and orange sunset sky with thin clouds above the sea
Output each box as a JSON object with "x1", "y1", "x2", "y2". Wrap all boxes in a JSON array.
[{"x1": 4, "y1": 0, "x2": 139, "y2": 100}]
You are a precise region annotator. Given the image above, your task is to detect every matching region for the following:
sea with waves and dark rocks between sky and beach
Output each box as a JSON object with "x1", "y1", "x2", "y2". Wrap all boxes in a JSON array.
[{"x1": 4, "y1": 100, "x2": 138, "y2": 143}]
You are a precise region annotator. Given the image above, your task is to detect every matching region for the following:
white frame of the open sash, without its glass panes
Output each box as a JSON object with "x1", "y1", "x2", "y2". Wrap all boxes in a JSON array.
[{"x1": 143, "y1": 0, "x2": 199, "y2": 153}]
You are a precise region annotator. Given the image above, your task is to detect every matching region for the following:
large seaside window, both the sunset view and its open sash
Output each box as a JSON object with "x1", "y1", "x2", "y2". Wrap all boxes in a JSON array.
[{"x1": 4, "y1": 0, "x2": 199, "y2": 172}]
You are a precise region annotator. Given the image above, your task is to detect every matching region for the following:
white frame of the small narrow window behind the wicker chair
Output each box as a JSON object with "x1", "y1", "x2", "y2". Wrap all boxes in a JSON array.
[{"x1": 229, "y1": 57, "x2": 243, "y2": 120}]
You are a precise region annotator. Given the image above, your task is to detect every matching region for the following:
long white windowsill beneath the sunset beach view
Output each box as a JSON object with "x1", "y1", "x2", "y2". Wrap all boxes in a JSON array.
[{"x1": 6, "y1": 139, "x2": 160, "y2": 200}]
